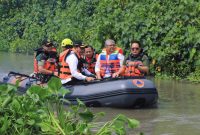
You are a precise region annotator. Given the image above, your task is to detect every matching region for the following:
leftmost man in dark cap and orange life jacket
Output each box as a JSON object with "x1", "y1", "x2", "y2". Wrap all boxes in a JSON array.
[{"x1": 33, "y1": 40, "x2": 58, "y2": 82}]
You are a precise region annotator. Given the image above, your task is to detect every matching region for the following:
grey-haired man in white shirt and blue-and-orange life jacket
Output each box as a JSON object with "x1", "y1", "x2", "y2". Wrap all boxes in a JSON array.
[{"x1": 95, "y1": 39, "x2": 124, "y2": 79}]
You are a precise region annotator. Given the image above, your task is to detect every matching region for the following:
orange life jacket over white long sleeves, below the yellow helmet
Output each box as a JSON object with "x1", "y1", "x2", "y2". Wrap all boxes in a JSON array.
[{"x1": 59, "y1": 49, "x2": 80, "y2": 79}]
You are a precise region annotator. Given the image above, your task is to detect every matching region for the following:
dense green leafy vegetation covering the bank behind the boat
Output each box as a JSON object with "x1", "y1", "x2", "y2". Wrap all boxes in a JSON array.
[{"x1": 0, "y1": 0, "x2": 200, "y2": 82}]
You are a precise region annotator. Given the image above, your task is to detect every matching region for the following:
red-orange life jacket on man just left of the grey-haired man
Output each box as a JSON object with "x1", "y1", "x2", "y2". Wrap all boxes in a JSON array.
[{"x1": 83, "y1": 54, "x2": 98, "y2": 74}]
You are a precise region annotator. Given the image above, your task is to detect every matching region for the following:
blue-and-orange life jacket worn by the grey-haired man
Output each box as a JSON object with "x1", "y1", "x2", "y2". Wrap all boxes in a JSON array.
[{"x1": 100, "y1": 50, "x2": 120, "y2": 77}]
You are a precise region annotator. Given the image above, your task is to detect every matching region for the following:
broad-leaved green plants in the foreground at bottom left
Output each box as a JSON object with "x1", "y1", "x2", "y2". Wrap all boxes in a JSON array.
[{"x1": 0, "y1": 78, "x2": 139, "y2": 135}]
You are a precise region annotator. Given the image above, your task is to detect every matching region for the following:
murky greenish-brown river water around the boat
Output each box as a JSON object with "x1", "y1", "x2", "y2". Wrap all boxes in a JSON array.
[{"x1": 0, "y1": 52, "x2": 200, "y2": 135}]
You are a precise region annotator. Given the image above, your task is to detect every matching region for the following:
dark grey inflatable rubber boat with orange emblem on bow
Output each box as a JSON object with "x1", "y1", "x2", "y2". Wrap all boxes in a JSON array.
[{"x1": 0, "y1": 72, "x2": 158, "y2": 108}]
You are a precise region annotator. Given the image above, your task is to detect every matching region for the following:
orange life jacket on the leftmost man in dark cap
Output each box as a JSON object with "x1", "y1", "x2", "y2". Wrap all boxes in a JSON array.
[{"x1": 33, "y1": 48, "x2": 57, "y2": 73}]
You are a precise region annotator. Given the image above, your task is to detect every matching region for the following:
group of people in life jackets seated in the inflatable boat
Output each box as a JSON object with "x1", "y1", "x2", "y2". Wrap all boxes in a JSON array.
[{"x1": 33, "y1": 38, "x2": 149, "y2": 85}]
